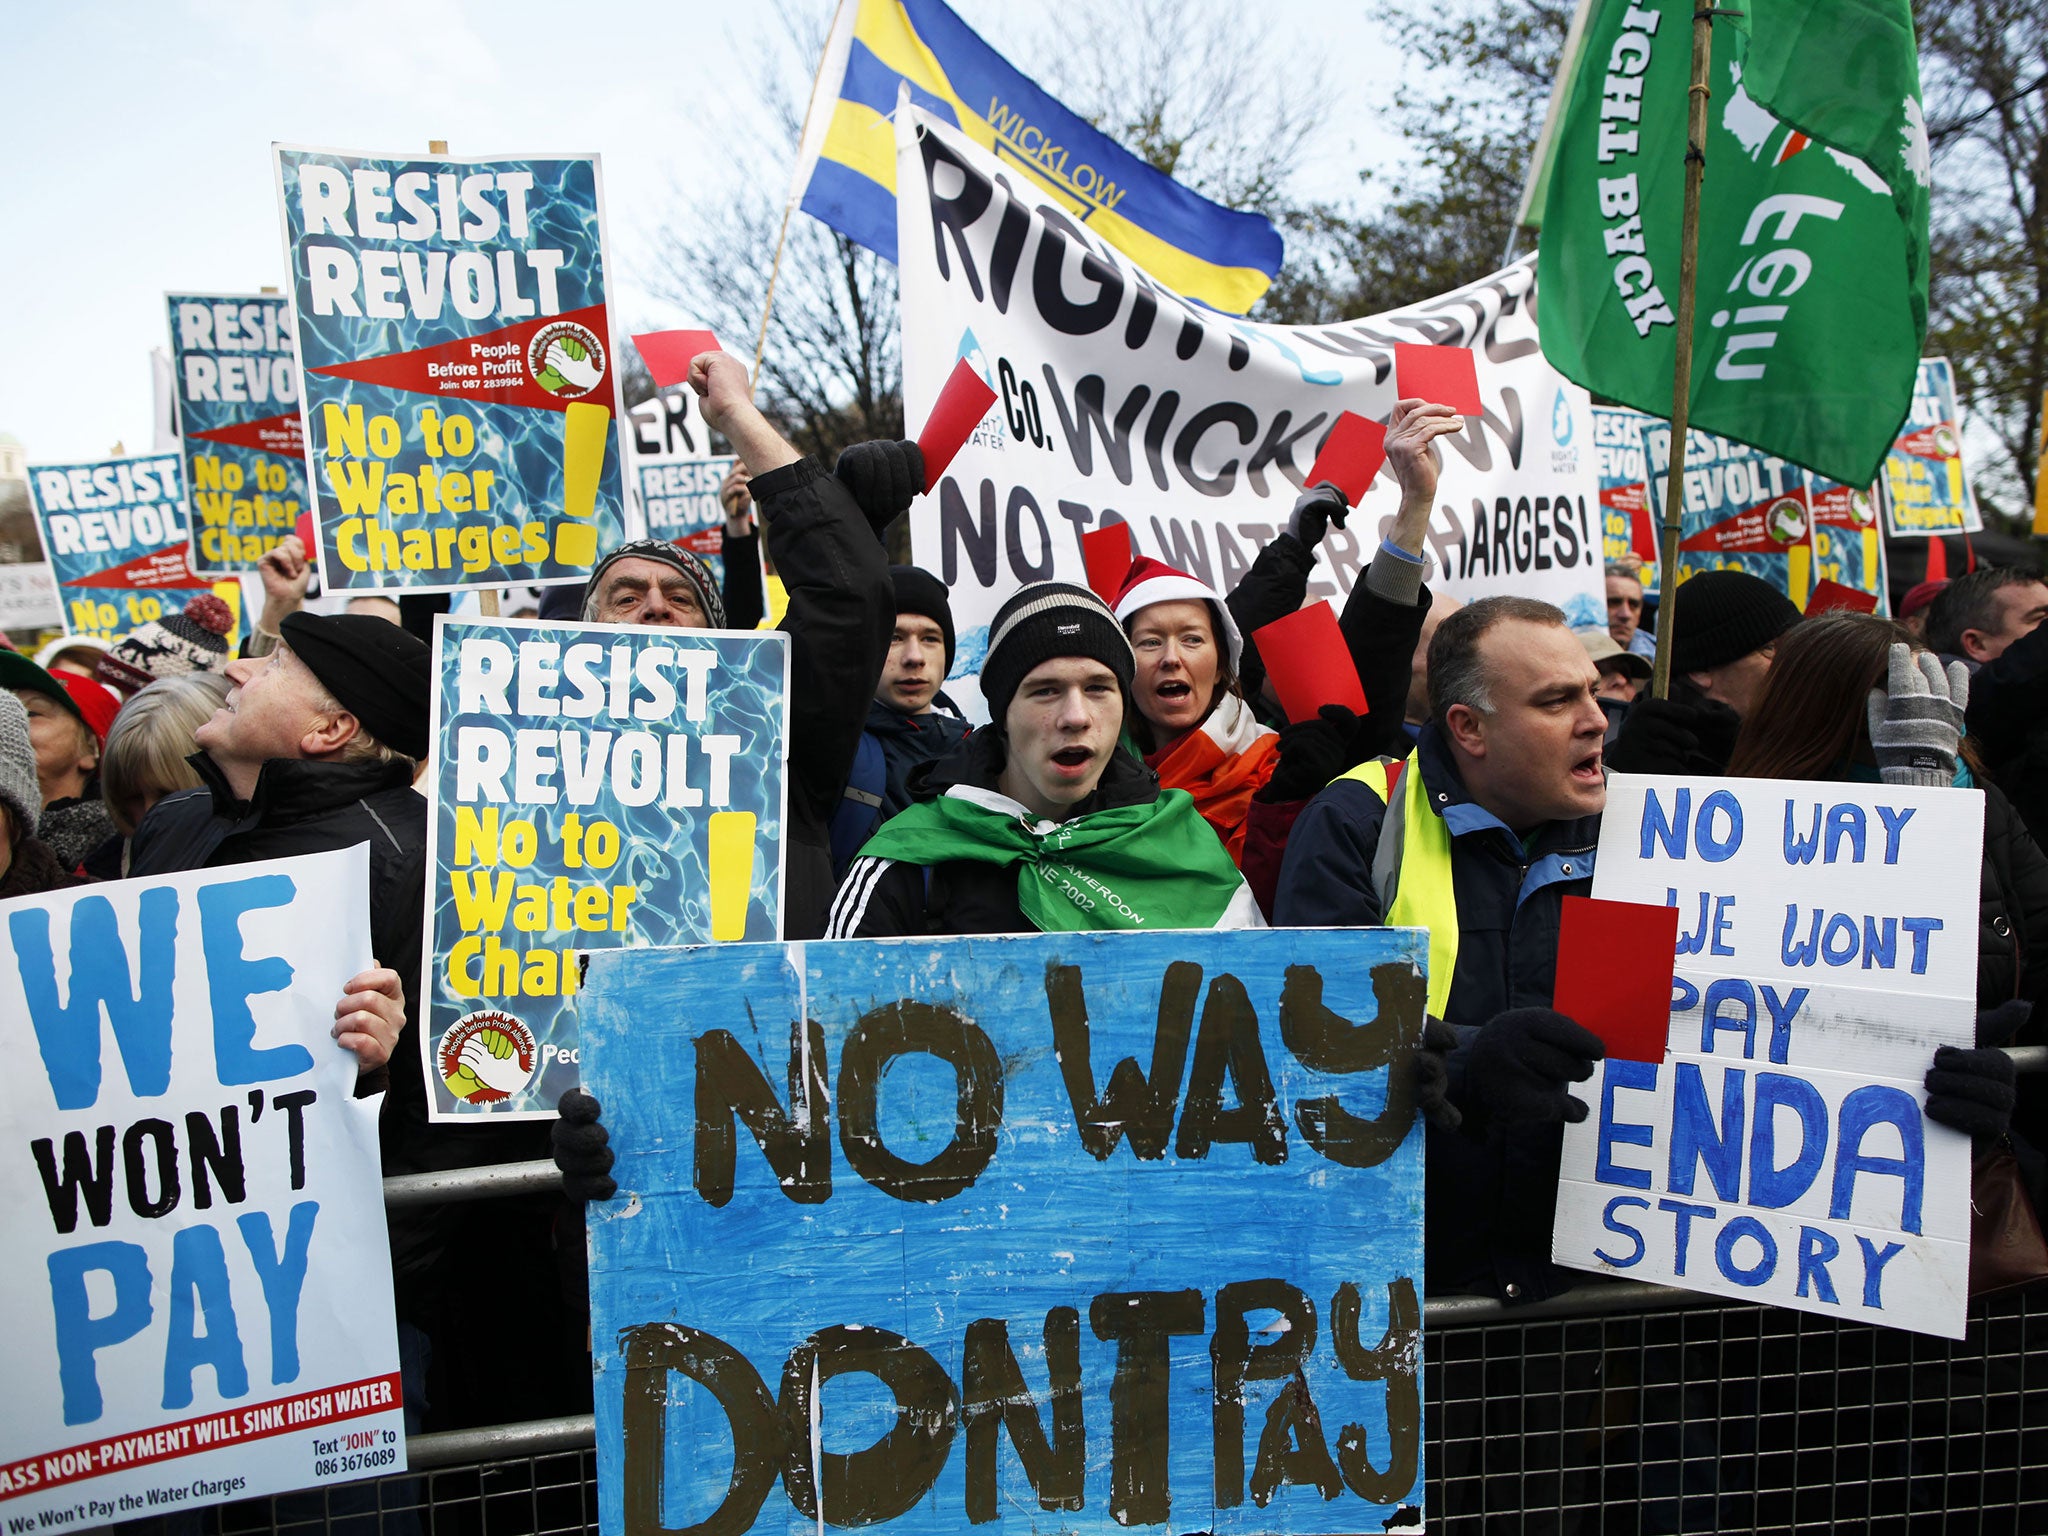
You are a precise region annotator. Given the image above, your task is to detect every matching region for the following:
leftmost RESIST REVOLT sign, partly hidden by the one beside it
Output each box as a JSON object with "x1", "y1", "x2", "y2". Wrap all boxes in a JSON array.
[{"x1": 29, "y1": 453, "x2": 242, "y2": 649}]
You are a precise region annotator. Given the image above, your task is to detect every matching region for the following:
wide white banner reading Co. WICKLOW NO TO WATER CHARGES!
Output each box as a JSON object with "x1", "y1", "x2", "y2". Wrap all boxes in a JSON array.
[{"x1": 897, "y1": 106, "x2": 1606, "y2": 711}]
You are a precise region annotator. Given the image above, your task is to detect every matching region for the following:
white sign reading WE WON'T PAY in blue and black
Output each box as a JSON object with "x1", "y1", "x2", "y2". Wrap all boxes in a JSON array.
[{"x1": 0, "y1": 846, "x2": 406, "y2": 1532}]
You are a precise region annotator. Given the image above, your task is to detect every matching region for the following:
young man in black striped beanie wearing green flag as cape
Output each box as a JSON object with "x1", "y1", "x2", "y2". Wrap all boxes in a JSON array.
[{"x1": 825, "y1": 582, "x2": 1266, "y2": 938}]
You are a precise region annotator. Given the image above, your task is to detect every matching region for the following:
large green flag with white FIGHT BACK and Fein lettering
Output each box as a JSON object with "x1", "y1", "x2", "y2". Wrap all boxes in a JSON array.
[{"x1": 1538, "y1": 0, "x2": 1927, "y2": 485}]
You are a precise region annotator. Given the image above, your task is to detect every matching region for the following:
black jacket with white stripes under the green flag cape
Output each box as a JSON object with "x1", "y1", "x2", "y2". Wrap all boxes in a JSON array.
[{"x1": 825, "y1": 727, "x2": 1159, "y2": 938}]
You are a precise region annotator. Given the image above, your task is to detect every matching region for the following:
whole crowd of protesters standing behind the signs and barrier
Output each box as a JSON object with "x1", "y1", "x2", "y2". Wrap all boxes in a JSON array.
[{"x1": 0, "y1": 354, "x2": 2048, "y2": 1466}]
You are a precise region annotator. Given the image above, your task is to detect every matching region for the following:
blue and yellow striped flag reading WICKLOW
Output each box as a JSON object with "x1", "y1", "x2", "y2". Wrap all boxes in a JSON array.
[{"x1": 795, "y1": 0, "x2": 1282, "y2": 315}]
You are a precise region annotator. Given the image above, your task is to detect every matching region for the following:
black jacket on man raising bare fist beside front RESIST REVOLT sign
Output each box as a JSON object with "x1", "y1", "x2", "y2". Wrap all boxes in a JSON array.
[{"x1": 750, "y1": 459, "x2": 895, "y2": 938}]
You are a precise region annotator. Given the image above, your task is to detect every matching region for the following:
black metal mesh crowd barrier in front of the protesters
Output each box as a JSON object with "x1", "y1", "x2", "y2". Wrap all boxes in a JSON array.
[{"x1": 219, "y1": 1047, "x2": 2048, "y2": 1536}]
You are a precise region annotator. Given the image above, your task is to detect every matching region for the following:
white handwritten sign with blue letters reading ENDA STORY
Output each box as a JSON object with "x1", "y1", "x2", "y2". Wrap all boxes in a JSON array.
[{"x1": 1552, "y1": 774, "x2": 1985, "y2": 1339}]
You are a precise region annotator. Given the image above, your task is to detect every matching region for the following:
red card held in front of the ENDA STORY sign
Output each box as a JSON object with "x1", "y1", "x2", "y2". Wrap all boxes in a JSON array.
[{"x1": 1550, "y1": 897, "x2": 1677, "y2": 1061}]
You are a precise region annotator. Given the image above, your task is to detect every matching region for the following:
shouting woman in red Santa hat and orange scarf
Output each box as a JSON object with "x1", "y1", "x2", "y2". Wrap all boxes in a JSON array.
[{"x1": 1116, "y1": 557, "x2": 1280, "y2": 862}]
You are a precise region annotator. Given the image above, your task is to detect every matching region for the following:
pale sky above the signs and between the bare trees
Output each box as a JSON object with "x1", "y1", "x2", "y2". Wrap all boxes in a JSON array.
[{"x1": 0, "y1": 0, "x2": 1397, "y2": 463}]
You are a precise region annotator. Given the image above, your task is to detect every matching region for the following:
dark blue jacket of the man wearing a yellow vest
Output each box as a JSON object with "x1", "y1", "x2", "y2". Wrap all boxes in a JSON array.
[{"x1": 1274, "y1": 725, "x2": 1599, "y2": 1300}]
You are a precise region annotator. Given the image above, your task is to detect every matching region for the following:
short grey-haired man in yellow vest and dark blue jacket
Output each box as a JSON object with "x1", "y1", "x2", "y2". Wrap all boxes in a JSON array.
[{"x1": 1274, "y1": 598, "x2": 1608, "y2": 1303}]
